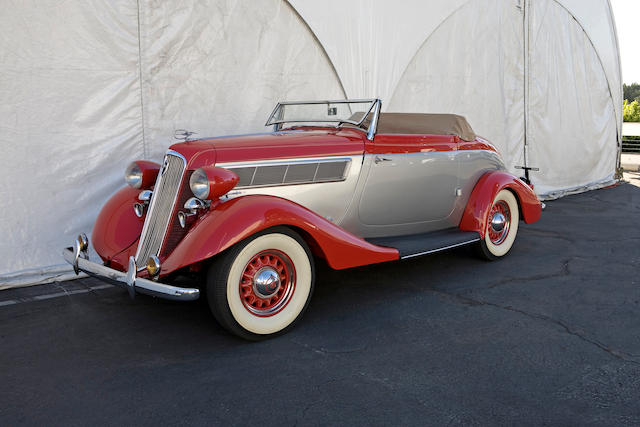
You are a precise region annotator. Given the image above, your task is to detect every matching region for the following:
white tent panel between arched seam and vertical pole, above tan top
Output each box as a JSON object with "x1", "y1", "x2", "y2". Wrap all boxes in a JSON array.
[{"x1": 388, "y1": 0, "x2": 525, "y2": 171}]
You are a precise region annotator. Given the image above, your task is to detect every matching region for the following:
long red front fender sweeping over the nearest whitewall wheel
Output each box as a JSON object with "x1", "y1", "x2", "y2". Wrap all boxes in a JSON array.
[{"x1": 162, "y1": 195, "x2": 399, "y2": 275}]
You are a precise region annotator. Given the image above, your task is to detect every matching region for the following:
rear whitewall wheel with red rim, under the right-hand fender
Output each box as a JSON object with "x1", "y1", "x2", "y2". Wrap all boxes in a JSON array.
[{"x1": 479, "y1": 190, "x2": 520, "y2": 261}]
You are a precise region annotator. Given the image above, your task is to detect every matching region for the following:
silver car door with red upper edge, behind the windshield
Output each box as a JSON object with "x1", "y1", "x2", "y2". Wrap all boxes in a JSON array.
[{"x1": 358, "y1": 134, "x2": 459, "y2": 234}]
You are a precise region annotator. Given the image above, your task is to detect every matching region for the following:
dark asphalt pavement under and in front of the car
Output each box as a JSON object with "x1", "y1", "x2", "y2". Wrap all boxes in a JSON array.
[{"x1": 0, "y1": 184, "x2": 640, "y2": 426}]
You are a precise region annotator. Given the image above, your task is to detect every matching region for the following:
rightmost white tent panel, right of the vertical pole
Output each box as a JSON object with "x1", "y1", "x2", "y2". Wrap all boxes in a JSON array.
[{"x1": 527, "y1": 1, "x2": 622, "y2": 196}]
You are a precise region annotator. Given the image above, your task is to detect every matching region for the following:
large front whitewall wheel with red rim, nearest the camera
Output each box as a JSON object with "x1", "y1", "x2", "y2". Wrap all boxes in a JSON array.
[{"x1": 207, "y1": 227, "x2": 314, "y2": 341}]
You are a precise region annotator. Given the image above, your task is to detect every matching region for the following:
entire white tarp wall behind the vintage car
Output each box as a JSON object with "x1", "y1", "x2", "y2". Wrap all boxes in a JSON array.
[{"x1": 0, "y1": 0, "x2": 622, "y2": 289}]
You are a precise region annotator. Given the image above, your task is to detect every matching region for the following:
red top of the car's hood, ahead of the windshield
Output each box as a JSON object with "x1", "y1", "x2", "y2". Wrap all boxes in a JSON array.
[{"x1": 170, "y1": 127, "x2": 366, "y2": 169}]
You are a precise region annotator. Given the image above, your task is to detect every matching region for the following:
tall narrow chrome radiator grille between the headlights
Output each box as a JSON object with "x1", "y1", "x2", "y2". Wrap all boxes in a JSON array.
[{"x1": 136, "y1": 151, "x2": 186, "y2": 270}]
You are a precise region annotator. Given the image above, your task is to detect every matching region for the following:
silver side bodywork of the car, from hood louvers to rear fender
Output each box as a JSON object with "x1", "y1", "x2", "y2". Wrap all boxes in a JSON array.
[{"x1": 217, "y1": 150, "x2": 505, "y2": 238}]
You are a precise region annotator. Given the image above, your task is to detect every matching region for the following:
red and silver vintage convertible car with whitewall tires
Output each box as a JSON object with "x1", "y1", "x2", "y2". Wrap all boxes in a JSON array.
[{"x1": 63, "y1": 99, "x2": 541, "y2": 340}]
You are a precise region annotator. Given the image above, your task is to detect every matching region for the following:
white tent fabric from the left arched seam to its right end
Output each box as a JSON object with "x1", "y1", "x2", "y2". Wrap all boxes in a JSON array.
[{"x1": 290, "y1": 0, "x2": 622, "y2": 194}]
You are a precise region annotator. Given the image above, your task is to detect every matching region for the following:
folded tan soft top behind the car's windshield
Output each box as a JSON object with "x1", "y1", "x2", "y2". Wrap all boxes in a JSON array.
[{"x1": 349, "y1": 112, "x2": 476, "y2": 141}]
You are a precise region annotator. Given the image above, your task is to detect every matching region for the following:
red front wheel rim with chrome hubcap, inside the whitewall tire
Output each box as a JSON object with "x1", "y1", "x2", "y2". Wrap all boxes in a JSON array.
[{"x1": 240, "y1": 249, "x2": 296, "y2": 317}]
